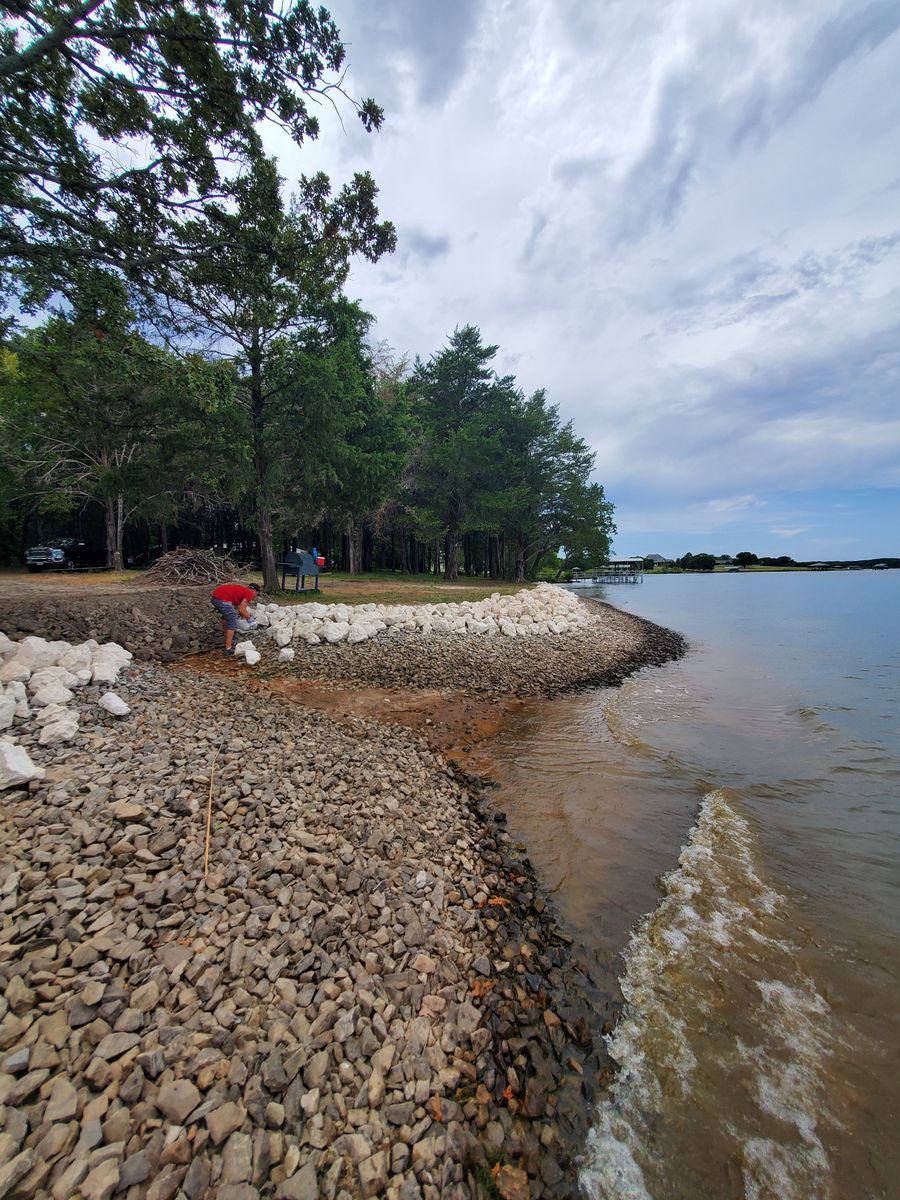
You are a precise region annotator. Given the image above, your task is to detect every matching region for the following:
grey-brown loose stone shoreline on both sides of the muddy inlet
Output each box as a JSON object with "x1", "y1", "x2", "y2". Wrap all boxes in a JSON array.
[{"x1": 0, "y1": 592, "x2": 683, "y2": 1200}]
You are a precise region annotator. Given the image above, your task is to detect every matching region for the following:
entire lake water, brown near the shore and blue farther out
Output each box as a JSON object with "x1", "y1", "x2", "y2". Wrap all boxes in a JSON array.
[{"x1": 487, "y1": 571, "x2": 900, "y2": 1200}]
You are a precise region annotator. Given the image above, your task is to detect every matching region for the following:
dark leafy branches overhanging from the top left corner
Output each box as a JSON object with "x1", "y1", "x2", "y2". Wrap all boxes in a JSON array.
[{"x1": 0, "y1": 0, "x2": 383, "y2": 302}]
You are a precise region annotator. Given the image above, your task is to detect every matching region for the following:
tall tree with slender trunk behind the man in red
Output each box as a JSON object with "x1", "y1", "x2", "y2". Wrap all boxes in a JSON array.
[{"x1": 157, "y1": 160, "x2": 396, "y2": 589}]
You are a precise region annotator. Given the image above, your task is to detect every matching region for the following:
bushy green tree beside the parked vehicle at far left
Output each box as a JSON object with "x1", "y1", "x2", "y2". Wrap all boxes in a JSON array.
[{"x1": 0, "y1": 276, "x2": 228, "y2": 570}]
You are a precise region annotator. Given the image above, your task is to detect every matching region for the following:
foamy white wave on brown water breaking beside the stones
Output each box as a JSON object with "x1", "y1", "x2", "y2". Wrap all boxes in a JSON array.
[{"x1": 581, "y1": 791, "x2": 835, "y2": 1200}]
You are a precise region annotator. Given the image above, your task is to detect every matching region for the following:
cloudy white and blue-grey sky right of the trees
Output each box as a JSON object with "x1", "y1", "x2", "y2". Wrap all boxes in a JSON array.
[{"x1": 273, "y1": 0, "x2": 900, "y2": 559}]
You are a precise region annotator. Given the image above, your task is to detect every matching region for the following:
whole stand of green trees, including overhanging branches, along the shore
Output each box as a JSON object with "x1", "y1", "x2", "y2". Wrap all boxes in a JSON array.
[{"x1": 0, "y1": 0, "x2": 613, "y2": 588}]
